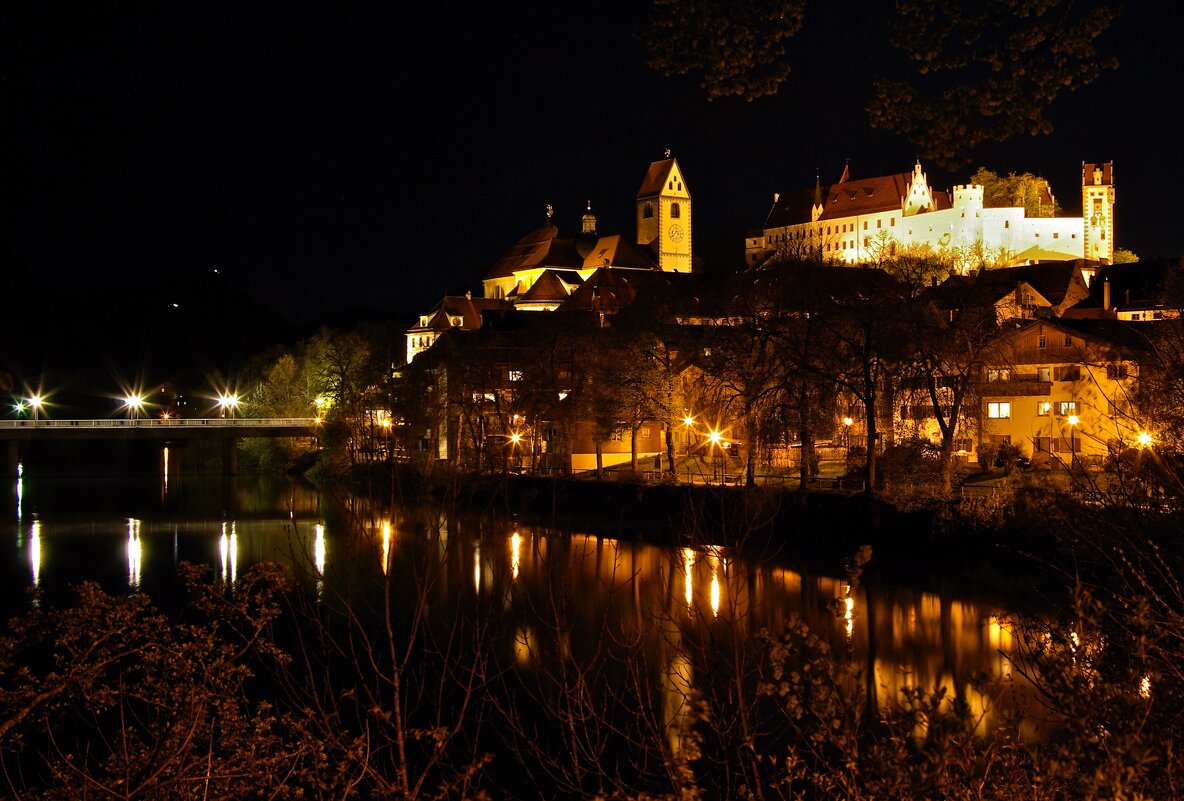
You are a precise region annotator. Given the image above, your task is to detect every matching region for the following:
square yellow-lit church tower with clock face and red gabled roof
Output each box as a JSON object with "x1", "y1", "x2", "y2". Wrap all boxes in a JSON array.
[{"x1": 637, "y1": 150, "x2": 691, "y2": 272}]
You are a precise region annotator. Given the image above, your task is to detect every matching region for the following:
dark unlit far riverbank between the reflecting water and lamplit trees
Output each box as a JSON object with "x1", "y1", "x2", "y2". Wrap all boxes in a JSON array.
[{"x1": 336, "y1": 465, "x2": 1064, "y2": 593}]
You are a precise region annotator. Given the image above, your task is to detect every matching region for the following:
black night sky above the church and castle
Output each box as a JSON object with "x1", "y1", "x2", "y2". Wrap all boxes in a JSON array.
[{"x1": 9, "y1": 0, "x2": 1184, "y2": 322}]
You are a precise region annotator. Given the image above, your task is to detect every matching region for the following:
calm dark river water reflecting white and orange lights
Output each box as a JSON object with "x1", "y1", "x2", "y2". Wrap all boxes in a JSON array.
[{"x1": 0, "y1": 461, "x2": 1046, "y2": 730}]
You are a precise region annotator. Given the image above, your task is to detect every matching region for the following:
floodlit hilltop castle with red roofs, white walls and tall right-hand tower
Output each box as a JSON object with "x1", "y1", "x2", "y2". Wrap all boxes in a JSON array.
[{"x1": 745, "y1": 162, "x2": 1114, "y2": 269}]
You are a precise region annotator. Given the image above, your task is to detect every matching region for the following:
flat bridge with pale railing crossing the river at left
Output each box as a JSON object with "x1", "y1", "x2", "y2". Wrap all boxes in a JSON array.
[{"x1": 0, "y1": 418, "x2": 320, "y2": 476}]
